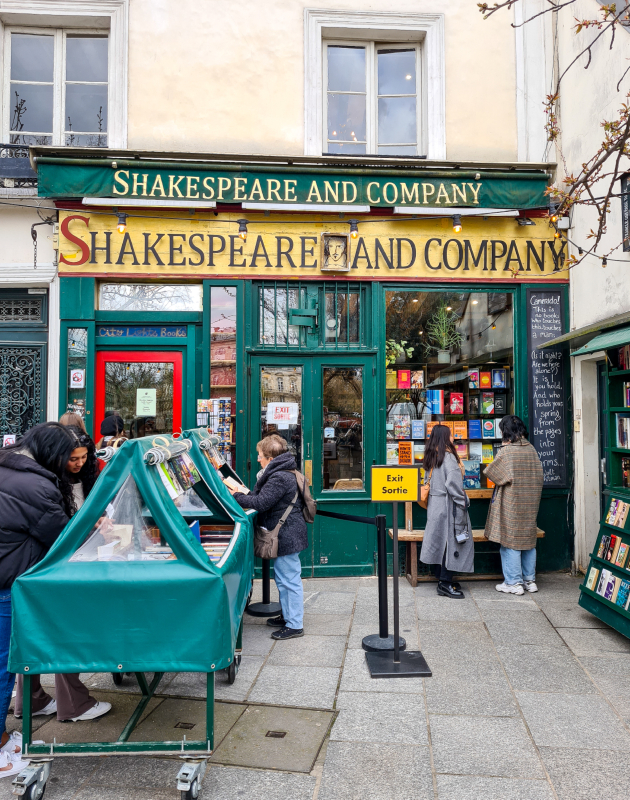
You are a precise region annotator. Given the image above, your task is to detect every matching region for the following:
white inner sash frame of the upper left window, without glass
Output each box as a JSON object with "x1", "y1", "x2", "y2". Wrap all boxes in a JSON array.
[{"x1": 2, "y1": 25, "x2": 111, "y2": 146}]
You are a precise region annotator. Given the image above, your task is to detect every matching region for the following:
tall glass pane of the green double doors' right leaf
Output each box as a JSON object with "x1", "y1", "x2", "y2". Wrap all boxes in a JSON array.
[{"x1": 322, "y1": 367, "x2": 363, "y2": 492}]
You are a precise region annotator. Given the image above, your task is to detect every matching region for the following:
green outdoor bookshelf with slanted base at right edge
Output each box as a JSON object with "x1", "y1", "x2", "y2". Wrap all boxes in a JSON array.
[{"x1": 579, "y1": 345, "x2": 630, "y2": 638}]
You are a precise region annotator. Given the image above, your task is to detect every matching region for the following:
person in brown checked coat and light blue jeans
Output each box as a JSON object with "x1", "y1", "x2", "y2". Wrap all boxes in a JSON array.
[{"x1": 484, "y1": 414, "x2": 543, "y2": 595}]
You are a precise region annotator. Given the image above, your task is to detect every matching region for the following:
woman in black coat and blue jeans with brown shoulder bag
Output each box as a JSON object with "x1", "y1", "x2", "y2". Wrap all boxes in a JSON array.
[{"x1": 232, "y1": 434, "x2": 308, "y2": 640}]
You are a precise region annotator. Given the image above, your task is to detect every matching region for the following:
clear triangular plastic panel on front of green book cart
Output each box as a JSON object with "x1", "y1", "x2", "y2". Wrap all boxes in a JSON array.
[{"x1": 70, "y1": 476, "x2": 176, "y2": 563}]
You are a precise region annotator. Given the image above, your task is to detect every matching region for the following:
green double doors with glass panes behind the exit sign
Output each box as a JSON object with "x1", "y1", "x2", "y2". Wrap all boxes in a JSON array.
[{"x1": 250, "y1": 354, "x2": 376, "y2": 577}]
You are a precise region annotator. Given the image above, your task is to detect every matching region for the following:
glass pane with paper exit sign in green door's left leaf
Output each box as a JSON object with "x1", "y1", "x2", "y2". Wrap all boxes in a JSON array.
[{"x1": 260, "y1": 367, "x2": 302, "y2": 470}]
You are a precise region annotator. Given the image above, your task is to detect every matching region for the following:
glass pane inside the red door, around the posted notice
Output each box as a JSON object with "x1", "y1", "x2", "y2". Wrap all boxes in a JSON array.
[{"x1": 105, "y1": 361, "x2": 173, "y2": 439}]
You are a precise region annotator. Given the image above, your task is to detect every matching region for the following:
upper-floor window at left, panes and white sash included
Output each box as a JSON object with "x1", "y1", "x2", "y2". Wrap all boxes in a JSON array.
[{"x1": 3, "y1": 29, "x2": 109, "y2": 147}]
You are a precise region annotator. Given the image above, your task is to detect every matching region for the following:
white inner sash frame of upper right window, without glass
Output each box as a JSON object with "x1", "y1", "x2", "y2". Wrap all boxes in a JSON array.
[{"x1": 322, "y1": 39, "x2": 425, "y2": 156}]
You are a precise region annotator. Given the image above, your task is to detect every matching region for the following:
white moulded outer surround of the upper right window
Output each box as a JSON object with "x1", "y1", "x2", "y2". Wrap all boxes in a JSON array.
[{"x1": 304, "y1": 8, "x2": 446, "y2": 161}]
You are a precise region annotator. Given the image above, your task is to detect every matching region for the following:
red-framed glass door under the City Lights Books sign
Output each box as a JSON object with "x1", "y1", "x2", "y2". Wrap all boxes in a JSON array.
[{"x1": 94, "y1": 350, "x2": 182, "y2": 442}]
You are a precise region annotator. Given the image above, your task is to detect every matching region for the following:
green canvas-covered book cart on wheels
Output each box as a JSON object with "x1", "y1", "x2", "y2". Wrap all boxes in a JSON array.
[{"x1": 9, "y1": 430, "x2": 254, "y2": 800}]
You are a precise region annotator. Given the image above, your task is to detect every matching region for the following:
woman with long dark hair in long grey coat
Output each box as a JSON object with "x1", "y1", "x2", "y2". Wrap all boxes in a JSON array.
[{"x1": 420, "y1": 425, "x2": 475, "y2": 598}]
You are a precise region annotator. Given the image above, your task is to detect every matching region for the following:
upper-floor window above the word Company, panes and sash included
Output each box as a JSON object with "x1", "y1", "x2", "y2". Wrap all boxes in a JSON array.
[{"x1": 323, "y1": 42, "x2": 422, "y2": 156}]
